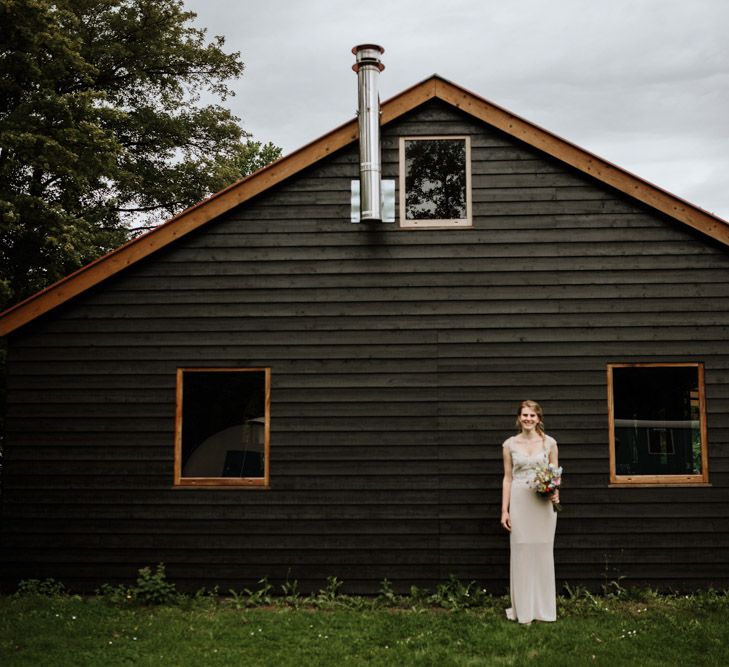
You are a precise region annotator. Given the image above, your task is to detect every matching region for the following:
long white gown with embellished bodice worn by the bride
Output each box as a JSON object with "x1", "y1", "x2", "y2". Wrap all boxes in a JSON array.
[{"x1": 503, "y1": 436, "x2": 557, "y2": 623}]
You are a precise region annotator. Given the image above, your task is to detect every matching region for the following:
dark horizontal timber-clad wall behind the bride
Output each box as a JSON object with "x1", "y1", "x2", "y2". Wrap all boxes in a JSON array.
[{"x1": 2, "y1": 103, "x2": 729, "y2": 592}]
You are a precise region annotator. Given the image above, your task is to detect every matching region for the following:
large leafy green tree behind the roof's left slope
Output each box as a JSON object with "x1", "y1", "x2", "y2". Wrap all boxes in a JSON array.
[{"x1": 0, "y1": 0, "x2": 281, "y2": 309}]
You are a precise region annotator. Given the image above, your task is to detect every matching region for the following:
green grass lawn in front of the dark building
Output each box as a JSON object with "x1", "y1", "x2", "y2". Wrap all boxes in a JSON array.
[{"x1": 0, "y1": 593, "x2": 729, "y2": 667}]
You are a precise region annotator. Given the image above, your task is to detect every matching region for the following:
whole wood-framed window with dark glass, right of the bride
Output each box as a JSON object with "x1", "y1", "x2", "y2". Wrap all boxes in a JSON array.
[{"x1": 607, "y1": 363, "x2": 709, "y2": 484}]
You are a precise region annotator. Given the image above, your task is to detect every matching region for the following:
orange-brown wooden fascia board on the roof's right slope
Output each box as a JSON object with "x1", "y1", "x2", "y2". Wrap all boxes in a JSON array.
[{"x1": 436, "y1": 79, "x2": 729, "y2": 246}]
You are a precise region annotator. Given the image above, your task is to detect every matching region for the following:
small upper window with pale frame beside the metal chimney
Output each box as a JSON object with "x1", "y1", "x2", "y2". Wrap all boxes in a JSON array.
[{"x1": 400, "y1": 136, "x2": 472, "y2": 227}]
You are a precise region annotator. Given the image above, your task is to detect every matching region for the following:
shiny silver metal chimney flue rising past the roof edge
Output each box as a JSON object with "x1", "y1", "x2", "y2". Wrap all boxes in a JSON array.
[{"x1": 352, "y1": 44, "x2": 385, "y2": 221}]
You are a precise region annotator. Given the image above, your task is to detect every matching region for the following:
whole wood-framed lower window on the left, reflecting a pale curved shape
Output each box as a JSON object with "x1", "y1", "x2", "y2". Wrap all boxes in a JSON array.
[{"x1": 175, "y1": 368, "x2": 271, "y2": 486}]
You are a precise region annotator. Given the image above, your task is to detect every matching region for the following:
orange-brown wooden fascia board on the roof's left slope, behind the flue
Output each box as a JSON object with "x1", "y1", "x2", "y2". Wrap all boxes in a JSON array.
[{"x1": 0, "y1": 78, "x2": 435, "y2": 336}]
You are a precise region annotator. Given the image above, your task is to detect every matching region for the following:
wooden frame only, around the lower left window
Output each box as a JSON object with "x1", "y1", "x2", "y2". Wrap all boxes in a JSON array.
[{"x1": 174, "y1": 367, "x2": 271, "y2": 489}]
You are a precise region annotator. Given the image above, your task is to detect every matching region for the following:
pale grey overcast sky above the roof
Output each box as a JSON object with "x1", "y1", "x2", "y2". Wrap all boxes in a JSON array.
[{"x1": 185, "y1": 0, "x2": 729, "y2": 220}]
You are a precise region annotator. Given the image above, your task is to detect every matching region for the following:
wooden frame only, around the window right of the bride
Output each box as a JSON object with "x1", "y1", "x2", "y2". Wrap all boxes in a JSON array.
[{"x1": 607, "y1": 362, "x2": 709, "y2": 487}]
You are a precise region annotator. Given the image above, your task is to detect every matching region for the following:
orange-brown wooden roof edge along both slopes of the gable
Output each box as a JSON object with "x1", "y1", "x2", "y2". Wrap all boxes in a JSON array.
[{"x1": 0, "y1": 76, "x2": 729, "y2": 335}]
